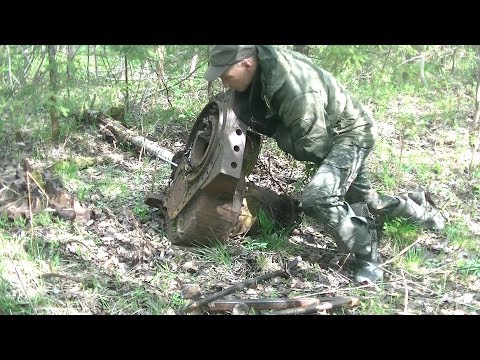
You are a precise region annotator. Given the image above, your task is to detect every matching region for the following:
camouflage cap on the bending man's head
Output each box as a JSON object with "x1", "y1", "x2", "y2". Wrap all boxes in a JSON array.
[{"x1": 204, "y1": 45, "x2": 257, "y2": 81}]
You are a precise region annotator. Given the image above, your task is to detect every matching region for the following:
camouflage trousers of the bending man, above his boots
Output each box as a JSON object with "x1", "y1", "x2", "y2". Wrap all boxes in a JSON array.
[{"x1": 301, "y1": 144, "x2": 399, "y2": 252}]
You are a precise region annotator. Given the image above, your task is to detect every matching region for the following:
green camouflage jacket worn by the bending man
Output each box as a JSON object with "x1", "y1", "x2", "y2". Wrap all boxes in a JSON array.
[{"x1": 246, "y1": 45, "x2": 376, "y2": 163}]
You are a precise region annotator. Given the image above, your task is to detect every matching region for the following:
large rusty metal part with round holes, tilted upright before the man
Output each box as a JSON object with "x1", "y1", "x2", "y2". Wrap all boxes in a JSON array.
[{"x1": 165, "y1": 91, "x2": 260, "y2": 246}]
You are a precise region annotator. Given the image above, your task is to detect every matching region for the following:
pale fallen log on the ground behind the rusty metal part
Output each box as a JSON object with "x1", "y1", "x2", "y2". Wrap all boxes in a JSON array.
[{"x1": 85, "y1": 110, "x2": 176, "y2": 166}]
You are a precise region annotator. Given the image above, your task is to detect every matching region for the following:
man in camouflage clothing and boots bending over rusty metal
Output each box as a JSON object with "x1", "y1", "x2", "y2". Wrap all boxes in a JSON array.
[{"x1": 205, "y1": 45, "x2": 444, "y2": 283}]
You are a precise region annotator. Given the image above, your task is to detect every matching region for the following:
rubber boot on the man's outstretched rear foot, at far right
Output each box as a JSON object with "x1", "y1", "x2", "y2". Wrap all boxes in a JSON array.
[{"x1": 390, "y1": 192, "x2": 445, "y2": 230}]
